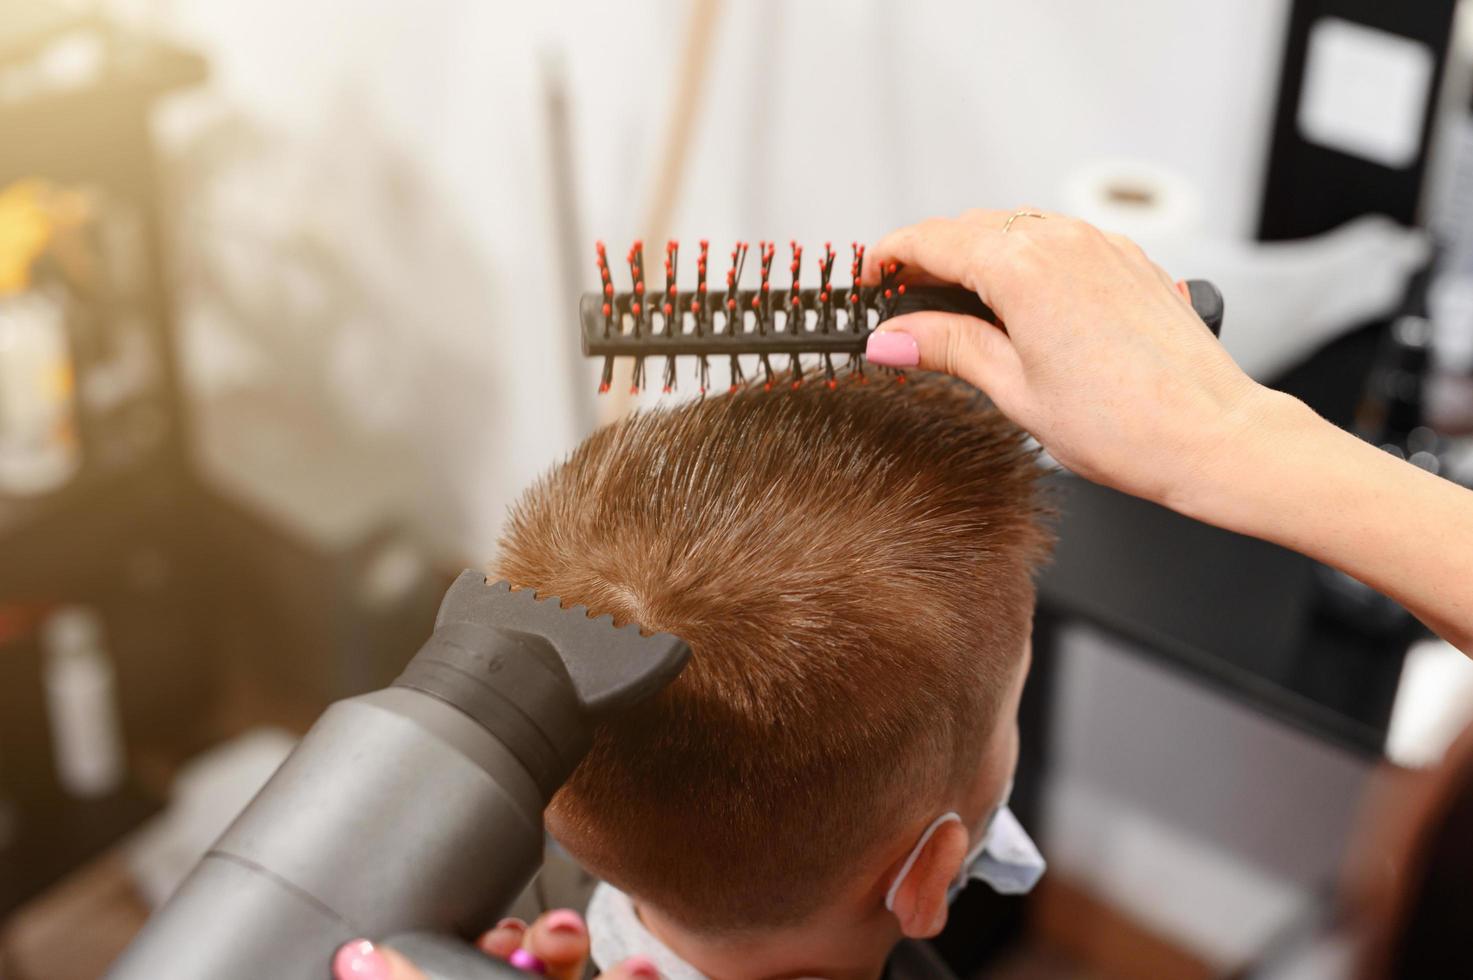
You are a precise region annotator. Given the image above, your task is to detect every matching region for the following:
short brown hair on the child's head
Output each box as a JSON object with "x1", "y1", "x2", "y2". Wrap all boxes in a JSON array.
[{"x1": 493, "y1": 374, "x2": 1050, "y2": 933}]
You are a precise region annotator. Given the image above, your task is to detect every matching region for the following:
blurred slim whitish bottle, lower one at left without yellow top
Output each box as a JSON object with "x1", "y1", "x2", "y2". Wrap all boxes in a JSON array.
[{"x1": 41, "y1": 606, "x2": 125, "y2": 797}]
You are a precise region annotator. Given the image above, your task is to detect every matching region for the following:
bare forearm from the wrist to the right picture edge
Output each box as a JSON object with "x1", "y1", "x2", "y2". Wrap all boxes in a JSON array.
[{"x1": 1184, "y1": 389, "x2": 1473, "y2": 656}]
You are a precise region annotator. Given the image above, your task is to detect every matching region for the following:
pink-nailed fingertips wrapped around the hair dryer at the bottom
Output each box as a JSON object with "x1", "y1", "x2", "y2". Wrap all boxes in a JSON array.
[{"x1": 333, "y1": 909, "x2": 660, "y2": 980}]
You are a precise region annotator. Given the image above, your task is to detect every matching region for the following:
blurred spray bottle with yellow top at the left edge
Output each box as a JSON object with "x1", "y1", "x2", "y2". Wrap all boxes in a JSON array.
[{"x1": 0, "y1": 181, "x2": 81, "y2": 497}]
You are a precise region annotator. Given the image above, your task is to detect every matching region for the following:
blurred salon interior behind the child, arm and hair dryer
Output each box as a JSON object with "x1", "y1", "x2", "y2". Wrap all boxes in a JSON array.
[{"x1": 0, "y1": 0, "x2": 1473, "y2": 980}]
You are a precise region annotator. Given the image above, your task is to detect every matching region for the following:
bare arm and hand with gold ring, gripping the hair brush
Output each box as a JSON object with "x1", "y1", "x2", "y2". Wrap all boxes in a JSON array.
[{"x1": 865, "y1": 211, "x2": 1473, "y2": 654}]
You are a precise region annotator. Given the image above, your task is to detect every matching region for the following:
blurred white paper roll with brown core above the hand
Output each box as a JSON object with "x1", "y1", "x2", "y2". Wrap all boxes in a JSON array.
[{"x1": 1064, "y1": 161, "x2": 1202, "y2": 243}]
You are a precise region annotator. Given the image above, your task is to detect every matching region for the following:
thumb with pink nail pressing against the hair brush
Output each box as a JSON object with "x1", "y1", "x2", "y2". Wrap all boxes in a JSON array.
[{"x1": 865, "y1": 311, "x2": 1022, "y2": 401}]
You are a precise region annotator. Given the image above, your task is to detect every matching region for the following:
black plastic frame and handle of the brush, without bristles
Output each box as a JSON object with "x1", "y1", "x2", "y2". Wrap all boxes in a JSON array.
[{"x1": 579, "y1": 279, "x2": 1223, "y2": 357}]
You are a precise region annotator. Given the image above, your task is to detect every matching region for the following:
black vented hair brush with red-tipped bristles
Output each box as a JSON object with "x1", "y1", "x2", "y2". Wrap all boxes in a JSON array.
[{"x1": 579, "y1": 239, "x2": 1223, "y2": 393}]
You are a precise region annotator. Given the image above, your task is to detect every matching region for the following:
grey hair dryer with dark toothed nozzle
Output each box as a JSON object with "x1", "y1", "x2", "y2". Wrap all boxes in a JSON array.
[{"x1": 108, "y1": 570, "x2": 689, "y2": 980}]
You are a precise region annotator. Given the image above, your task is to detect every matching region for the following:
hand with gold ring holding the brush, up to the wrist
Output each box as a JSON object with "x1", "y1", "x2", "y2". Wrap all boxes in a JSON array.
[{"x1": 865, "y1": 211, "x2": 1271, "y2": 504}]
